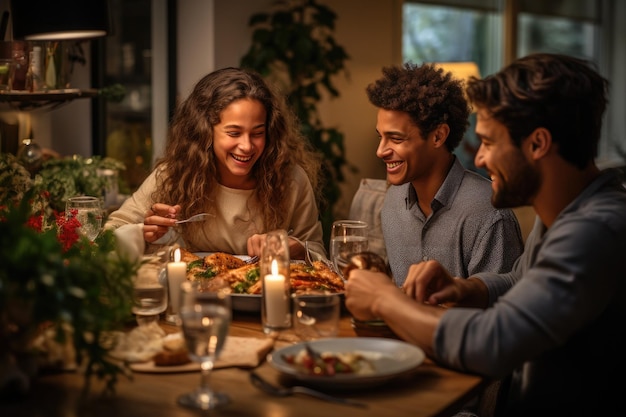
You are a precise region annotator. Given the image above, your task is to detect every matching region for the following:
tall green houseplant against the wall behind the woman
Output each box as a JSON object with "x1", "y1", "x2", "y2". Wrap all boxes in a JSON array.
[{"x1": 240, "y1": 0, "x2": 356, "y2": 244}]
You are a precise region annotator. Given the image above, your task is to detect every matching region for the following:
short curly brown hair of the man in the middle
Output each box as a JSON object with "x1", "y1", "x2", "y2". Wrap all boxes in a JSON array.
[{"x1": 366, "y1": 62, "x2": 470, "y2": 152}]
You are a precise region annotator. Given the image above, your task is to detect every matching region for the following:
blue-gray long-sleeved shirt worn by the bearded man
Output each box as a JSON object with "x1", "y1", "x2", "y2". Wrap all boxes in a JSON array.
[{"x1": 433, "y1": 168, "x2": 626, "y2": 416}]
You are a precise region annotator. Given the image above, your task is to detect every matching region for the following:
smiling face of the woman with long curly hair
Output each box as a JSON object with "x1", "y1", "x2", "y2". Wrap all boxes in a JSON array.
[{"x1": 213, "y1": 99, "x2": 267, "y2": 189}]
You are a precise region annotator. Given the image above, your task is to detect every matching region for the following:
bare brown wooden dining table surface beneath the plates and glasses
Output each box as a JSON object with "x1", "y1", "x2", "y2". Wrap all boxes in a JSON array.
[{"x1": 0, "y1": 313, "x2": 487, "y2": 417}]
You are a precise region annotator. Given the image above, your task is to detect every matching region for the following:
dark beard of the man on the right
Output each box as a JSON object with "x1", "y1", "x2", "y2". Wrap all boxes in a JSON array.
[{"x1": 491, "y1": 153, "x2": 541, "y2": 208}]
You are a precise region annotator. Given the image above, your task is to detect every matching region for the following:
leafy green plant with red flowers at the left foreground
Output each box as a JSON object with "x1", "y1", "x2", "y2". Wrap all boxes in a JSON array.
[{"x1": 0, "y1": 154, "x2": 139, "y2": 398}]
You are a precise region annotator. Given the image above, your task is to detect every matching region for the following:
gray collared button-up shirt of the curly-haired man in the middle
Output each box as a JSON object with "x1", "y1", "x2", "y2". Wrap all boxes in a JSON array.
[{"x1": 381, "y1": 159, "x2": 523, "y2": 286}]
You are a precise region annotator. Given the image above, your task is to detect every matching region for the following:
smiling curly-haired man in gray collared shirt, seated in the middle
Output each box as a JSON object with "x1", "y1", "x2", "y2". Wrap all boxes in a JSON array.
[{"x1": 366, "y1": 63, "x2": 523, "y2": 286}]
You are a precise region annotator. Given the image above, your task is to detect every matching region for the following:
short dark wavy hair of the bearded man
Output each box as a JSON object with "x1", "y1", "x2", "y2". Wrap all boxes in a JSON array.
[{"x1": 467, "y1": 53, "x2": 609, "y2": 169}]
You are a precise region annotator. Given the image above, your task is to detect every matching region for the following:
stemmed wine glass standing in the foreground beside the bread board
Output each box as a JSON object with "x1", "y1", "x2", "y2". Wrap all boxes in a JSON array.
[{"x1": 178, "y1": 281, "x2": 232, "y2": 410}]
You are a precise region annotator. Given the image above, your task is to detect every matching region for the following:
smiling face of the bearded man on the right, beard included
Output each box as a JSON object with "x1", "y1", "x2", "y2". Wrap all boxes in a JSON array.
[{"x1": 474, "y1": 109, "x2": 541, "y2": 208}]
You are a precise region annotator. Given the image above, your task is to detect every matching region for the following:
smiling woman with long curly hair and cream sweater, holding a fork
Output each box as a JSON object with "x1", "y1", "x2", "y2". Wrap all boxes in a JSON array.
[{"x1": 107, "y1": 68, "x2": 326, "y2": 258}]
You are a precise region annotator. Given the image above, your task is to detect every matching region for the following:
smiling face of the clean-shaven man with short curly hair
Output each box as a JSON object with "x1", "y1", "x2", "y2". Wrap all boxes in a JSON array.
[{"x1": 376, "y1": 109, "x2": 438, "y2": 185}]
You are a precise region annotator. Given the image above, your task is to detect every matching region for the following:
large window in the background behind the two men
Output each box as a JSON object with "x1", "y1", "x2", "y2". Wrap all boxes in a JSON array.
[{"x1": 402, "y1": 0, "x2": 626, "y2": 169}]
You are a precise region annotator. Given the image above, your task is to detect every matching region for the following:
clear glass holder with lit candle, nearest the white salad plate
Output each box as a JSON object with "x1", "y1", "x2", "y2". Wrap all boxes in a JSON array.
[{"x1": 259, "y1": 230, "x2": 291, "y2": 334}]
